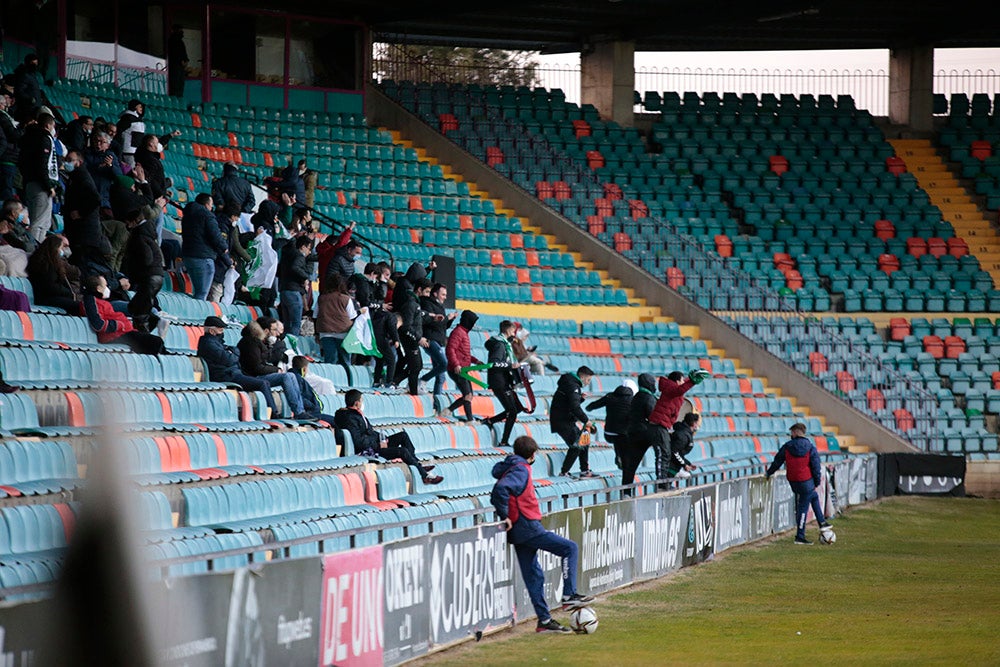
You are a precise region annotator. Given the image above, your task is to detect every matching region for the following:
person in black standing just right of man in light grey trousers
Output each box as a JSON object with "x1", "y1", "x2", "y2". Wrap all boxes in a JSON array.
[{"x1": 63, "y1": 150, "x2": 111, "y2": 276}]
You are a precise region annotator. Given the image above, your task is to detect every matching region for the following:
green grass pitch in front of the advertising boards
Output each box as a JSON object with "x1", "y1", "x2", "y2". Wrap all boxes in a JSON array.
[{"x1": 421, "y1": 497, "x2": 1000, "y2": 667}]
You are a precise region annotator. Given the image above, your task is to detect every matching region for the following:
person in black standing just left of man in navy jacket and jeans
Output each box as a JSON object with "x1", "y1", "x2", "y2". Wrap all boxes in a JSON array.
[{"x1": 122, "y1": 209, "x2": 163, "y2": 332}]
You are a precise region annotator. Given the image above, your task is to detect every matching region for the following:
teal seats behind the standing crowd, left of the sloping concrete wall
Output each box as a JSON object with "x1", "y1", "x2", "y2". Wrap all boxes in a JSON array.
[{"x1": 48, "y1": 80, "x2": 628, "y2": 314}]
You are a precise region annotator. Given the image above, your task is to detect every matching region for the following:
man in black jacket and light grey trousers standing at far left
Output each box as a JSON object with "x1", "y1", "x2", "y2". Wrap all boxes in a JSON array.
[{"x1": 17, "y1": 113, "x2": 59, "y2": 243}]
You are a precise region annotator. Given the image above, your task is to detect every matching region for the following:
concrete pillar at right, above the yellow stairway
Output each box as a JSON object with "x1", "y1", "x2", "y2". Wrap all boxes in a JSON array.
[{"x1": 889, "y1": 46, "x2": 934, "y2": 132}]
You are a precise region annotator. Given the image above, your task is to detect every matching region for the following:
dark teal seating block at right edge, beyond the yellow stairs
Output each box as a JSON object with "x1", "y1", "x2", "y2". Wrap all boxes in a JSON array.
[{"x1": 939, "y1": 93, "x2": 1000, "y2": 210}]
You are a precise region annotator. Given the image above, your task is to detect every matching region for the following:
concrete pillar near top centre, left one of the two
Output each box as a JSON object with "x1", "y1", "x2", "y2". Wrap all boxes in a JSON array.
[{"x1": 580, "y1": 42, "x2": 635, "y2": 127}]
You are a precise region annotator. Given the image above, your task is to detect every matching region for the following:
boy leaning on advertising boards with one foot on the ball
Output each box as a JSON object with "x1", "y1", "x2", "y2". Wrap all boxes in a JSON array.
[{"x1": 490, "y1": 435, "x2": 594, "y2": 632}]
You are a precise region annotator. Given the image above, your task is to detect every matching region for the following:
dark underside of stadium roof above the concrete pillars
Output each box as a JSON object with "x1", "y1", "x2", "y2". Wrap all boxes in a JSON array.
[{"x1": 308, "y1": 0, "x2": 1000, "y2": 53}]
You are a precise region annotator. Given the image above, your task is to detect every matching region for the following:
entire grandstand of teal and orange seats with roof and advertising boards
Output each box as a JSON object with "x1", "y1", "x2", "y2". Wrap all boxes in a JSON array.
[{"x1": 0, "y1": 0, "x2": 1000, "y2": 665}]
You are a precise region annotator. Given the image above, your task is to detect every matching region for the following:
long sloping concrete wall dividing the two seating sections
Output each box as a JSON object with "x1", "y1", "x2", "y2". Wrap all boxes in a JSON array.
[{"x1": 366, "y1": 86, "x2": 916, "y2": 452}]
